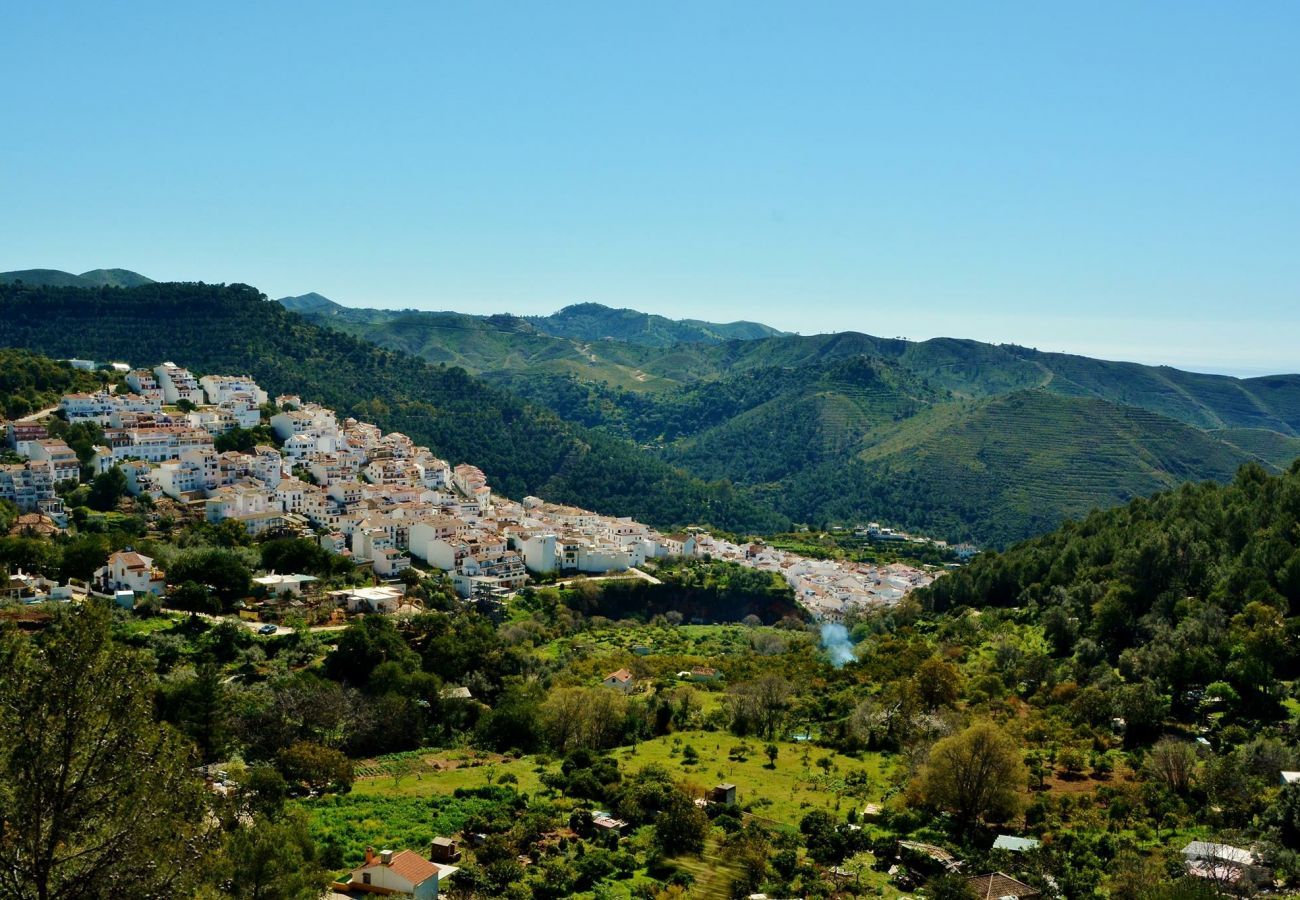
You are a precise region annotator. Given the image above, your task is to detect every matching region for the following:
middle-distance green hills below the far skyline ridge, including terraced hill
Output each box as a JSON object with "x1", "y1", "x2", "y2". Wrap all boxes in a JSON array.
[{"x1": 507, "y1": 356, "x2": 1284, "y2": 545}]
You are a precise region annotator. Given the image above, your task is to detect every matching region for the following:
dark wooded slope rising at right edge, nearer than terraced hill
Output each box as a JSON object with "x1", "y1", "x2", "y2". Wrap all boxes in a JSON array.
[{"x1": 919, "y1": 463, "x2": 1300, "y2": 714}]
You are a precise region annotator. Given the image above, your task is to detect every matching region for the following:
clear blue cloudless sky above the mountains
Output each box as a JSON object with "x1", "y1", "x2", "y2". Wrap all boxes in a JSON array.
[{"x1": 0, "y1": 0, "x2": 1300, "y2": 375}]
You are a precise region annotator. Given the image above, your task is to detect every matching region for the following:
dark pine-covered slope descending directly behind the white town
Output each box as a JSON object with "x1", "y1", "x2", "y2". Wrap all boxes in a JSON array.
[{"x1": 0, "y1": 284, "x2": 785, "y2": 531}]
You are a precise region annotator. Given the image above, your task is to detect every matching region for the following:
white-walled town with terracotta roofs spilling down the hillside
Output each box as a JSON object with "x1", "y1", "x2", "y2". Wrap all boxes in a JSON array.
[{"x1": 0, "y1": 360, "x2": 933, "y2": 622}]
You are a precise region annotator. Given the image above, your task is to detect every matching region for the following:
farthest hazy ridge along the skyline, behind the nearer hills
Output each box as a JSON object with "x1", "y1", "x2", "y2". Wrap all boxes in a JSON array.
[{"x1": 283, "y1": 295, "x2": 1300, "y2": 437}]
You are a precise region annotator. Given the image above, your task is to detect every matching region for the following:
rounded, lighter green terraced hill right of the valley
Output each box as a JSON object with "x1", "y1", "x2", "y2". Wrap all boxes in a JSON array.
[{"x1": 775, "y1": 390, "x2": 1277, "y2": 546}]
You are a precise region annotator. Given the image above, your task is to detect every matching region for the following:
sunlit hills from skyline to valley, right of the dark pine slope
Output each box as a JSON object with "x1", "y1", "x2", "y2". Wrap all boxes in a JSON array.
[{"x1": 274, "y1": 295, "x2": 1300, "y2": 545}]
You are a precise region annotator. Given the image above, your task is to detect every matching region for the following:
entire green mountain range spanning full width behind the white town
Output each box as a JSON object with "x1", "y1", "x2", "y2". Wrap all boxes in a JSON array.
[{"x1": 0, "y1": 271, "x2": 1300, "y2": 546}]
